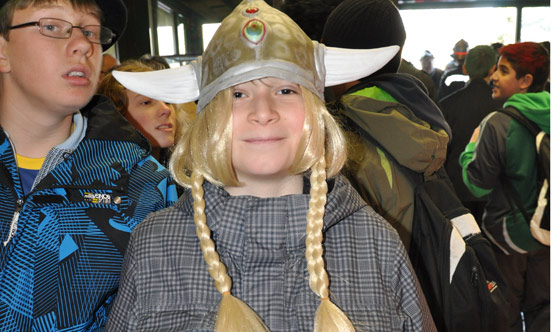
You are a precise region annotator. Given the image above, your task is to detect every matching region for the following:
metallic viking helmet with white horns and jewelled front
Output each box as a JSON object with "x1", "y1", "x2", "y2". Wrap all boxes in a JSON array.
[{"x1": 113, "y1": 0, "x2": 399, "y2": 112}]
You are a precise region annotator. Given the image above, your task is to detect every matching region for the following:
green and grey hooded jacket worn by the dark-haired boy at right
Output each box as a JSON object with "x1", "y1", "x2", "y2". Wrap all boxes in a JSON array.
[{"x1": 459, "y1": 91, "x2": 550, "y2": 250}]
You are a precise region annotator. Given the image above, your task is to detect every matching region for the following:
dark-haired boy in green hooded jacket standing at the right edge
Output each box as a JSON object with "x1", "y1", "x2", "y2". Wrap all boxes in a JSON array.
[{"x1": 460, "y1": 42, "x2": 550, "y2": 332}]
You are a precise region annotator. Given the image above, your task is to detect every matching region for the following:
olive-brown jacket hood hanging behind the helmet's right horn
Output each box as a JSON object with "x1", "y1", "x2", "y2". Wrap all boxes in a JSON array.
[{"x1": 338, "y1": 75, "x2": 450, "y2": 175}]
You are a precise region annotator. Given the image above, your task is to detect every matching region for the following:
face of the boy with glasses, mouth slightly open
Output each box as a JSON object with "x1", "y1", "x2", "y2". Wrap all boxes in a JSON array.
[{"x1": 0, "y1": 1, "x2": 102, "y2": 115}]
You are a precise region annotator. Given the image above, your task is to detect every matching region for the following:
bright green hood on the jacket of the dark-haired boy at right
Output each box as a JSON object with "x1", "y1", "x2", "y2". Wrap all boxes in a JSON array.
[{"x1": 504, "y1": 91, "x2": 550, "y2": 134}]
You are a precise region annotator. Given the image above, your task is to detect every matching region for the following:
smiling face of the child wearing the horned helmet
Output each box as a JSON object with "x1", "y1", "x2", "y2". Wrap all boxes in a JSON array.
[{"x1": 232, "y1": 77, "x2": 305, "y2": 184}]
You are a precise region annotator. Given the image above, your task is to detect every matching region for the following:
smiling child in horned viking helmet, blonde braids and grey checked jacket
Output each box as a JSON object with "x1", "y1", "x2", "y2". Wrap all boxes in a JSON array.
[{"x1": 106, "y1": 0, "x2": 435, "y2": 332}]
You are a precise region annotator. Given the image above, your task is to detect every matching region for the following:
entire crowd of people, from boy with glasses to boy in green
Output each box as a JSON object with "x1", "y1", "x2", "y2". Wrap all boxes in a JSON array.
[{"x1": 0, "y1": 0, "x2": 550, "y2": 332}]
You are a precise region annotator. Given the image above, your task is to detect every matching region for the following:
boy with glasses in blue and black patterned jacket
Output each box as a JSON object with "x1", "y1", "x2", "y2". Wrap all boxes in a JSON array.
[{"x1": 0, "y1": 0, "x2": 176, "y2": 331}]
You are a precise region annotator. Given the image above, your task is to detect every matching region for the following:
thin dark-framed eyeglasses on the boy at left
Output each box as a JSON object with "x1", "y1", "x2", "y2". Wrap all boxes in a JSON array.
[{"x1": 8, "y1": 18, "x2": 116, "y2": 45}]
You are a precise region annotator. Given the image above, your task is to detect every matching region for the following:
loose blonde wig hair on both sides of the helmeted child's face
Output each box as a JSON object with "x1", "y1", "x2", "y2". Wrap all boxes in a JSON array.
[{"x1": 169, "y1": 87, "x2": 347, "y2": 188}]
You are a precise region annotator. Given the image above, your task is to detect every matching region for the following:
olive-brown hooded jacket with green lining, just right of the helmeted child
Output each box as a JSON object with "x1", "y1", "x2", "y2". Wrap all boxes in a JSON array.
[{"x1": 334, "y1": 76, "x2": 449, "y2": 250}]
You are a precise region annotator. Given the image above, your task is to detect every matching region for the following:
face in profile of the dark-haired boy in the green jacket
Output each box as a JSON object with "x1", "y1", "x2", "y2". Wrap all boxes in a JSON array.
[{"x1": 491, "y1": 57, "x2": 527, "y2": 100}]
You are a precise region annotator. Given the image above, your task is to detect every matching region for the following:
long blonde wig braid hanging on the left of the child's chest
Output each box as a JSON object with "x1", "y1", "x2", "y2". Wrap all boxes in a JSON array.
[{"x1": 191, "y1": 171, "x2": 268, "y2": 332}]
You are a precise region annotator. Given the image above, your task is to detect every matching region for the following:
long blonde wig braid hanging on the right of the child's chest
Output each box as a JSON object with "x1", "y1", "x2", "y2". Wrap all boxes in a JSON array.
[{"x1": 305, "y1": 154, "x2": 355, "y2": 332}]
